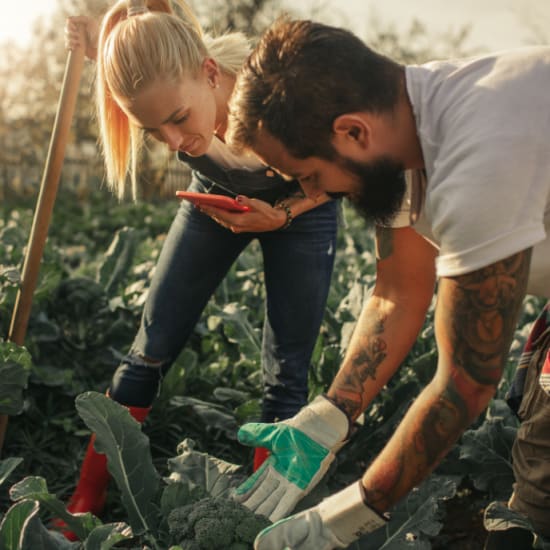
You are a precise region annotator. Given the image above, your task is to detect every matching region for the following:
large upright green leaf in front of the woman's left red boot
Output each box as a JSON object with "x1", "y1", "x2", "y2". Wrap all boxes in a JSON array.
[{"x1": 76, "y1": 392, "x2": 160, "y2": 535}]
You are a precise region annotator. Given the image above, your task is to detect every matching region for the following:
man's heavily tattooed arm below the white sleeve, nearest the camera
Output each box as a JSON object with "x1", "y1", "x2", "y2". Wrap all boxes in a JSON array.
[{"x1": 363, "y1": 250, "x2": 531, "y2": 511}]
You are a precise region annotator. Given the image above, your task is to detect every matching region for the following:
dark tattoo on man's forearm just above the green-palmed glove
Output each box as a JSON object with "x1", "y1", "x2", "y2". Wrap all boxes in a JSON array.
[{"x1": 332, "y1": 317, "x2": 387, "y2": 419}]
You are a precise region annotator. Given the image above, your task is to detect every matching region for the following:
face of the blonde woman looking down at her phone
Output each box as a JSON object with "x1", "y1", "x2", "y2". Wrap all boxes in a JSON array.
[{"x1": 121, "y1": 71, "x2": 219, "y2": 157}]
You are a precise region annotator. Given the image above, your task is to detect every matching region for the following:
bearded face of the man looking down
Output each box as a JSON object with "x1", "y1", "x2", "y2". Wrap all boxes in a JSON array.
[{"x1": 254, "y1": 132, "x2": 405, "y2": 223}]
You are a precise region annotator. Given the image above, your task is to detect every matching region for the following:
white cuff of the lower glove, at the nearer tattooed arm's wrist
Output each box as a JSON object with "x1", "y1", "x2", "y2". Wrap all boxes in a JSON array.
[{"x1": 318, "y1": 481, "x2": 388, "y2": 545}]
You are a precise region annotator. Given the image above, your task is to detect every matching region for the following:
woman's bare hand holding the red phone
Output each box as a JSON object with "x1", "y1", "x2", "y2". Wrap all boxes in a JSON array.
[{"x1": 200, "y1": 195, "x2": 287, "y2": 233}]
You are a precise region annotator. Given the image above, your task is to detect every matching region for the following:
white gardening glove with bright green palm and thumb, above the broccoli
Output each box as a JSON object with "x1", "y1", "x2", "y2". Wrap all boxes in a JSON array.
[{"x1": 232, "y1": 396, "x2": 350, "y2": 521}]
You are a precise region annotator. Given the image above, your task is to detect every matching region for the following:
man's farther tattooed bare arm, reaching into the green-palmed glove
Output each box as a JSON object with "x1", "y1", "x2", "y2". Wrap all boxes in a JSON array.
[{"x1": 327, "y1": 228, "x2": 437, "y2": 420}]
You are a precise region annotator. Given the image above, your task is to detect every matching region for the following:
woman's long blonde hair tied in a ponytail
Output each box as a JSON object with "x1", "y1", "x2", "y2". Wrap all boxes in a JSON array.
[{"x1": 96, "y1": 0, "x2": 250, "y2": 199}]
